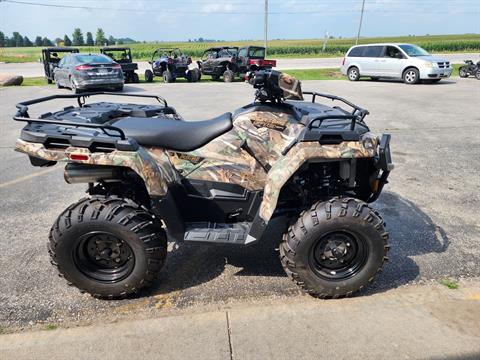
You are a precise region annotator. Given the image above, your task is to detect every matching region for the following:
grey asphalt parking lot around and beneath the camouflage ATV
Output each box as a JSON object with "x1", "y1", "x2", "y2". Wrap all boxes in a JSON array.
[{"x1": 0, "y1": 78, "x2": 480, "y2": 329}]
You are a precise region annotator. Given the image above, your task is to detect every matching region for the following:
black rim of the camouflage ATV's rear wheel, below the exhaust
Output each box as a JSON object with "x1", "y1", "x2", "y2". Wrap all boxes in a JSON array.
[{"x1": 73, "y1": 231, "x2": 135, "y2": 283}]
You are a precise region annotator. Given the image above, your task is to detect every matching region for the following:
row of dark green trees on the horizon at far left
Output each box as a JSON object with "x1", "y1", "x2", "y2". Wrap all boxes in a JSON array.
[{"x1": 0, "y1": 28, "x2": 123, "y2": 47}]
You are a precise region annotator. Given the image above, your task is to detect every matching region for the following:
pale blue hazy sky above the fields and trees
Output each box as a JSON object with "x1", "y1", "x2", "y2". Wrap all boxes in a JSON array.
[{"x1": 0, "y1": 0, "x2": 480, "y2": 41}]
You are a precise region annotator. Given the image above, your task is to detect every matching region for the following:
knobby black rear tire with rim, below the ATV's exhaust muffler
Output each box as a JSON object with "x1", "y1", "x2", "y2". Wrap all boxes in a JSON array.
[{"x1": 49, "y1": 196, "x2": 167, "y2": 298}]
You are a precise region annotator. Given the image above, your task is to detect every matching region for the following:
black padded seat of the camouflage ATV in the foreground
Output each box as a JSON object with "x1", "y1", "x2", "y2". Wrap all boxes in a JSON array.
[{"x1": 112, "y1": 113, "x2": 232, "y2": 151}]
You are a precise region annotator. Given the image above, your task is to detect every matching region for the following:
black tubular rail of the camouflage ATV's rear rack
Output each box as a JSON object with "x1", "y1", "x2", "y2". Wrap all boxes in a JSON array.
[{"x1": 13, "y1": 91, "x2": 168, "y2": 140}]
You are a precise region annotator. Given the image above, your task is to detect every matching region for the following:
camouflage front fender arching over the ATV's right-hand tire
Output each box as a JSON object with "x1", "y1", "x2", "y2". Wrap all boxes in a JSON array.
[{"x1": 260, "y1": 139, "x2": 377, "y2": 222}]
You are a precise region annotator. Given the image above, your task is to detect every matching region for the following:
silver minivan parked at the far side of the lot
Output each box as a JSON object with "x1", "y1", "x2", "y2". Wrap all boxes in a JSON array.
[{"x1": 342, "y1": 44, "x2": 452, "y2": 84}]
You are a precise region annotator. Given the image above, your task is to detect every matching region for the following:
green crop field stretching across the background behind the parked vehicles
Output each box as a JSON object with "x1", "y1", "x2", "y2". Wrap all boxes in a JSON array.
[{"x1": 0, "y1": 34, "x2": 480, "y2": 62}]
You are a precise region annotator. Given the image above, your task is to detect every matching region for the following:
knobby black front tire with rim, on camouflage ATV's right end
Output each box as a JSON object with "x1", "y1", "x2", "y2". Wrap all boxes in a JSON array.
[{"x1": 280, "y1": 198, "x2": 389, "y2": 298}]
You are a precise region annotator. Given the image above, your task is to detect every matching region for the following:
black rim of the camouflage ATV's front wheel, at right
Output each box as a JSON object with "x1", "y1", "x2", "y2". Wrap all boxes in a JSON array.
[{"x1": 309, "y1": 231, "x2": 368, "y2": 280}]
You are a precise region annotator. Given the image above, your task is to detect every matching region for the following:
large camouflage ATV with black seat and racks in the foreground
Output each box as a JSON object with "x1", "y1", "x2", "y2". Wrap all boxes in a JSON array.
[{"x1": 14, "y1": 71, "x2": 393, "y2": 298}]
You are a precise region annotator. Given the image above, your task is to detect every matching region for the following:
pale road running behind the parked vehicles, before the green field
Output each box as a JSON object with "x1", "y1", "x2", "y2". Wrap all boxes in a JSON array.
[{"x1": 0, "y1": 53, "x2": 480, "y2": 77}]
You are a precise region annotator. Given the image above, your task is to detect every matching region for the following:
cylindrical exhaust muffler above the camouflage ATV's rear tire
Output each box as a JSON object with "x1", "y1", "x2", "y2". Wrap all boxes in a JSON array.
[{"x1": 64, "y1": 163, "x2": 125, "y2": 184}]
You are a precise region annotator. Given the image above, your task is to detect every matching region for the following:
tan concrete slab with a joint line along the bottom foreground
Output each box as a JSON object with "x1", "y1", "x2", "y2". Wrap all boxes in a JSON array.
[{"x1": 0, "y1": 279, "x2": 480, "y2": 360}]
